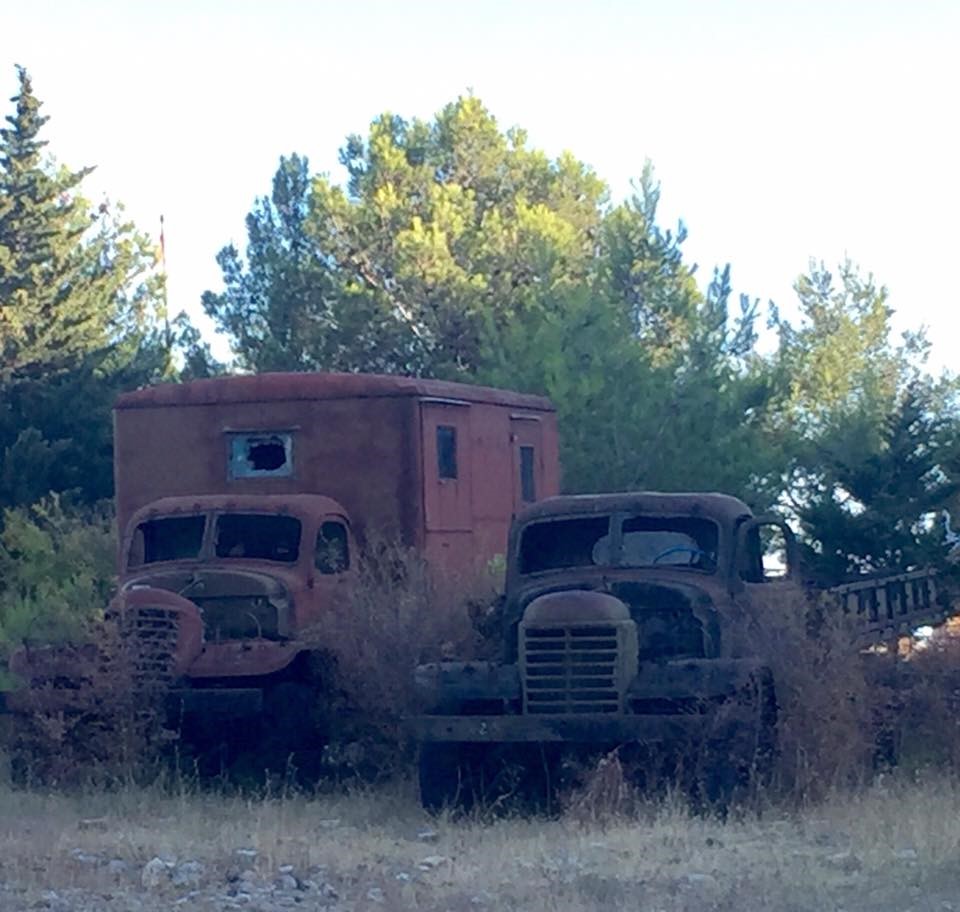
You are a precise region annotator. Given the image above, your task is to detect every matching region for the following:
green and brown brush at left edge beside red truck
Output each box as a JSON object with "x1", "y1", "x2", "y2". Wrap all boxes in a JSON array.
[{"x1": 0, "y1": 495, "x2": 170, "y2": 783}]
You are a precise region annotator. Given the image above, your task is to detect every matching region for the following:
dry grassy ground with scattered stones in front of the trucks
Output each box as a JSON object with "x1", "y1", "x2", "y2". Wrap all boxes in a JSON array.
[{"x1": 0, "y1": 778, "x2": 960, "y2": 912}]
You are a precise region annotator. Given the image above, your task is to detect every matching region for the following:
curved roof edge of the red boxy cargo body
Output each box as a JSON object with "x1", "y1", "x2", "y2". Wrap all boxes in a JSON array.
[{"x1": 114, "y1": 373, "x2": 554, "y2": 412}]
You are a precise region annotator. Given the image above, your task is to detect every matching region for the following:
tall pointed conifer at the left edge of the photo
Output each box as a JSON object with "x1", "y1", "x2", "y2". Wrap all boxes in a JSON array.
[{"x1": 0, "y1": 68, "x2": 168, "y2": 506}]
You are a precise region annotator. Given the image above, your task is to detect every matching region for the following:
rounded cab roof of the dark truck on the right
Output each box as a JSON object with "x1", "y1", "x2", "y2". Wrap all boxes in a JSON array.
[{"x1": 518, "y1": 491, "x2": 753, "y2": 523}]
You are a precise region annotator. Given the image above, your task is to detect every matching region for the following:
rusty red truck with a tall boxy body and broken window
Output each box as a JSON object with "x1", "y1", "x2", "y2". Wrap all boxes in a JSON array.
[{"x1": 8, "y1": 373, "x2": 559, "y2": 764}]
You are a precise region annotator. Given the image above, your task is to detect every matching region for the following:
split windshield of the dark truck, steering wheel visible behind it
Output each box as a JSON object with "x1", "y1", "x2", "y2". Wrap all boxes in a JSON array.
[{"x1": 520, "y1": 516, "x2": 718, "y2": 573}]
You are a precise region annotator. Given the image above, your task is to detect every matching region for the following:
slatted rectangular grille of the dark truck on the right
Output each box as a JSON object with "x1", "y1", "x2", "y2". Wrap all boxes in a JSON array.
[{"x1": 520, "y1": 624, "x2": 625, "y2": 715}]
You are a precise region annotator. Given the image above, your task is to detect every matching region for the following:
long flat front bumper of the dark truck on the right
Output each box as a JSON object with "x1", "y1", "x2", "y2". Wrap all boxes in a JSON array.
[{"x1": 410, "y1": 713, "x2": 705, "y2": 744}]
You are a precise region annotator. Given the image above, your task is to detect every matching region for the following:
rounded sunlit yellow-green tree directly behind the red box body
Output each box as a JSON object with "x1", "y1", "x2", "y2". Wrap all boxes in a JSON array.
[{"x1": 204, "y1": 97, "x2": 606, "y2": 377}]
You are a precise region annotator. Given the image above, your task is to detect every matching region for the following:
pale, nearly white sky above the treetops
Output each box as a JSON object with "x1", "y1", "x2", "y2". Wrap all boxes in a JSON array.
[{"x1": 0, "y1": 0, "x2": 960, "y2": 370}]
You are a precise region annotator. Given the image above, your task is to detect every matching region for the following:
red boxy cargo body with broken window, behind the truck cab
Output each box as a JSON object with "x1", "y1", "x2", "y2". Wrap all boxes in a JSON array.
[{"x1": 115, "y1": 374, "x2": 559, "y2": 571}]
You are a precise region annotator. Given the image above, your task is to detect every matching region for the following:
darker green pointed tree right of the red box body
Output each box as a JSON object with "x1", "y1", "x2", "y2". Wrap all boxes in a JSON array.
[{"x1": 479, "y1": 178, "x2": 781, "y2": 508}]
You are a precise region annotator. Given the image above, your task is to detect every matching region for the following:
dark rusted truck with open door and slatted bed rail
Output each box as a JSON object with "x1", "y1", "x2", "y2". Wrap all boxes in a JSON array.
[{"x1": 411, "y1": 493, "x2": 946, "y2": 809}]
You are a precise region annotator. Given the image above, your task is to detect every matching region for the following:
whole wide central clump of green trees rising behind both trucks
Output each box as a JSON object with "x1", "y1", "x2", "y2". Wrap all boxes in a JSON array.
[{"x1": 204, "y1": 97, "x2": 777, "y2": 505}]
